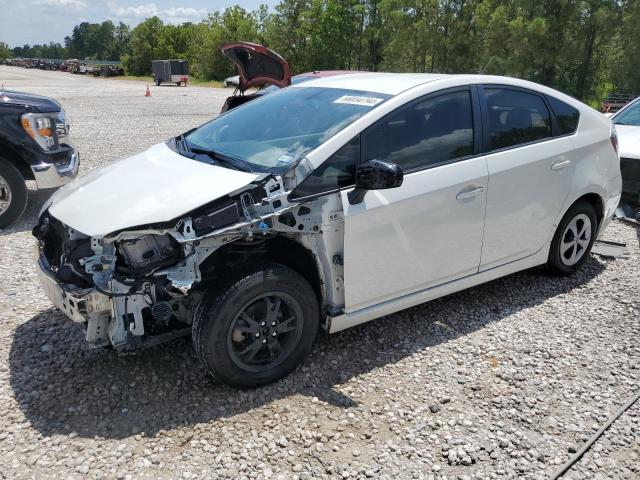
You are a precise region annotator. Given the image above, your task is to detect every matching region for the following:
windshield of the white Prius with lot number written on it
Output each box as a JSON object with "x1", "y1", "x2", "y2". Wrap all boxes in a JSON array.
[{"x1": 184, "y1": 87, "x2": 389, "y2": 173}]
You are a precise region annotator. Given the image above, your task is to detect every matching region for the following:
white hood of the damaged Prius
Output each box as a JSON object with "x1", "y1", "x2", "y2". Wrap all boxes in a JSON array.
[{"x1": 50, "y1": 143, "x2": 258, "y2": 238}]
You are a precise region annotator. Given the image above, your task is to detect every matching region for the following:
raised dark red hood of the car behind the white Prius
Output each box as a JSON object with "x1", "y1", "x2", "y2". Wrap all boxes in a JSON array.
[{"x1": 222, "y1": 42, "x2": 291, "y2": 92}]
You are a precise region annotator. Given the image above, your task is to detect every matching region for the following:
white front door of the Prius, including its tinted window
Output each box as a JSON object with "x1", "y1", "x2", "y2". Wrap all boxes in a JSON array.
[{"x1": 342, "y1": 88, "x2": 488, "y2": 313}]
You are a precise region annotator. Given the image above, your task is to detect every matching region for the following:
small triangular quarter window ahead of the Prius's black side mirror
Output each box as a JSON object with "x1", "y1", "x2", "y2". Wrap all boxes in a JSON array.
[{"x1": 291, "y1": 135, "x2": 360, "y2": 198}]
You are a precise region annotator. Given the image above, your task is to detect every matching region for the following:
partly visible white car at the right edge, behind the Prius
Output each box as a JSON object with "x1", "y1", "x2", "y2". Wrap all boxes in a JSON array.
[{"x1": 611, "y1": 97, "x2": 640, "y2": 203}]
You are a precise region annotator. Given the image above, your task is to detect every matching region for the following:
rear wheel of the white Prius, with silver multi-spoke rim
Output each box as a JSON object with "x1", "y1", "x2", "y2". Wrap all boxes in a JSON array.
[{"x1": 547, "y1": 201, "x2": 598, "y2": 275}]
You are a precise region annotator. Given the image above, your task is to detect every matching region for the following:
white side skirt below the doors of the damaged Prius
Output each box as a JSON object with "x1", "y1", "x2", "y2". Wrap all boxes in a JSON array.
[{"x1": 328, "y1": 245, "x2": 550, "y2": 333}]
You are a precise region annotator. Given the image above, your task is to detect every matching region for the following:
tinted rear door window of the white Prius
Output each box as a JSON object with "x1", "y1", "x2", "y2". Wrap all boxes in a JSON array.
[{"x1": 484, "y1": 88, "x2": 551, "y2": 150}]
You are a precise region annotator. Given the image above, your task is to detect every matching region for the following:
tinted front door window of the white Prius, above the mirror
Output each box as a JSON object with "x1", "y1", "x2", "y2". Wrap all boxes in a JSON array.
[{"x1": 362, "y1": 90, "x2": 473, "y2": 171}]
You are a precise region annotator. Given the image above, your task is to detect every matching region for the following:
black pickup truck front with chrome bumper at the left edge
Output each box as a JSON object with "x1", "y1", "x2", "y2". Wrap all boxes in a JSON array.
[{"x1": 0, "y1": 90, "x2": 79, "y2": 227}]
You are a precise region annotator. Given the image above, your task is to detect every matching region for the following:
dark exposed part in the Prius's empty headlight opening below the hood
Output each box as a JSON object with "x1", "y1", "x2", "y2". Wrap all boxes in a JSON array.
[{"x1": 118, "y1": 235, "x2": 182, "y2": 277}]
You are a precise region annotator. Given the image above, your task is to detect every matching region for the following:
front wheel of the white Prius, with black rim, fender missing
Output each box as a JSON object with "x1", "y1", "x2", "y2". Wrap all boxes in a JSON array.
[{"x1": 193, "y1": 263, "x2": 320, "y2": 388}]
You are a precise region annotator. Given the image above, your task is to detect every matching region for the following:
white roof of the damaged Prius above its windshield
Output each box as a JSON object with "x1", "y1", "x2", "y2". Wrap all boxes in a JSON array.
[{"x1": 291, "y1": 72, "x2": 451, "y2": 95}]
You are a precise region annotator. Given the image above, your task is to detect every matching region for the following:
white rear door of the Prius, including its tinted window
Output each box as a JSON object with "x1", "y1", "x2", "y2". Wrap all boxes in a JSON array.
[{"x1": 480, "y1": 85, "x2": 575, "y2": 271}]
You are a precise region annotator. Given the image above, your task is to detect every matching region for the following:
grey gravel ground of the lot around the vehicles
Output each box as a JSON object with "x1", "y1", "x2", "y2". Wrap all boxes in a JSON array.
[{"x1": 0, "y1": 67, "x2": 640, "y2": 479}]
